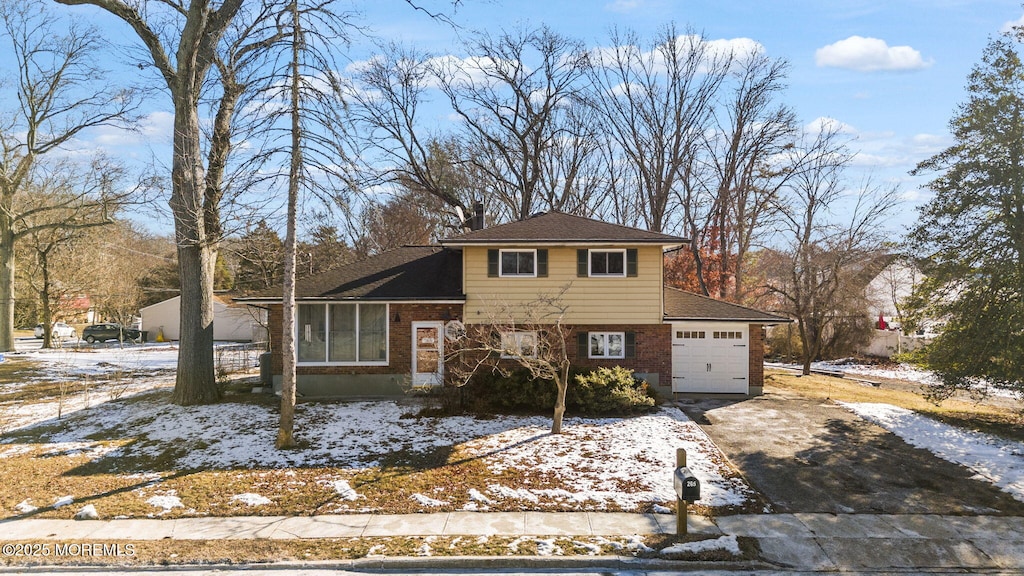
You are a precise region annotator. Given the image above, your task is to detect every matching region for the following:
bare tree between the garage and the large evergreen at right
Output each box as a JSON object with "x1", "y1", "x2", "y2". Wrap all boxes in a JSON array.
[{"x1": 767, "y1": 126, "x2": 898, "y2": 375}]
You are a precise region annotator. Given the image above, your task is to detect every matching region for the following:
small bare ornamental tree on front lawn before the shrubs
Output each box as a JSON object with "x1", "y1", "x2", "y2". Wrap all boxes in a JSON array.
[{"x1": 445, "y1": 284, "x2": 571, "y2": 434}]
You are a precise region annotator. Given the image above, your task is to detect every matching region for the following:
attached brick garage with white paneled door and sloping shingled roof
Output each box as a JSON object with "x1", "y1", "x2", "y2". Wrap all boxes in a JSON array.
[{"x1": 665, "y1": 287, "x2": 790, "y2": 396}]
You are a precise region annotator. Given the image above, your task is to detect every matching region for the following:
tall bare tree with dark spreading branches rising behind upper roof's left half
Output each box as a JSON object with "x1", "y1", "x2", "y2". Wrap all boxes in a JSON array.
[{"x1": 431, "y1": 27, "x2": 590, "y2": 220}]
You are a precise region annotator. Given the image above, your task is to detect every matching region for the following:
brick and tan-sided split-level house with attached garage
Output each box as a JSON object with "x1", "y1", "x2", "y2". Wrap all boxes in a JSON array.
[{"x1": 238, "y1": 212, "x2": 788, "y2": 397}]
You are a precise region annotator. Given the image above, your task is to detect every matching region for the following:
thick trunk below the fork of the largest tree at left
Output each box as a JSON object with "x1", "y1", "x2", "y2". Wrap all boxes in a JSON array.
[{"x1": 170, "y1": 91, "x2": 220, "y2": 406}]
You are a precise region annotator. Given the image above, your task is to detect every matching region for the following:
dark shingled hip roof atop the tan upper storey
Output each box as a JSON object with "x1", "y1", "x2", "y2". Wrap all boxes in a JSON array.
[{"x1": 441, "y1": 212, "x2": 688, "y2": 246}]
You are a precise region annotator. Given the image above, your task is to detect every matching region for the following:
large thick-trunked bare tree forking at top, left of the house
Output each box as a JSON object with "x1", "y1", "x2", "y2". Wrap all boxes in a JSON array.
[{"x1": 55, "y1": 0, "x2": 251, "y2": 405}]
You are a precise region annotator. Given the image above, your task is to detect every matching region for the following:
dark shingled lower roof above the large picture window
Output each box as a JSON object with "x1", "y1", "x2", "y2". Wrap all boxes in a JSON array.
[{"x1": 239, "y1": 246, "x2": 465, "y2": 301}]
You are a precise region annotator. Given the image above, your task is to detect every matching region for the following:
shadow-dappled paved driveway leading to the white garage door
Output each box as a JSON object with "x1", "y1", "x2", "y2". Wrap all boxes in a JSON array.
[{"x1": 681, "y1": 387, "x2": 1024, "y2": 516}]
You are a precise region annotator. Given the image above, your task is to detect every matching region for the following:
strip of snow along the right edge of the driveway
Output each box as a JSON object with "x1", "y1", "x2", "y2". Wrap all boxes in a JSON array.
[{"x1": 841, "y1": 403, "x2": 1024, "y2": 501}]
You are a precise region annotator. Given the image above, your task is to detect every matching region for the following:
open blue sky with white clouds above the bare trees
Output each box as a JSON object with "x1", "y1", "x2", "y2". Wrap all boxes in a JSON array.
[{"x1": 12, "y1": 0, "x2": 1024, "y2": 233}]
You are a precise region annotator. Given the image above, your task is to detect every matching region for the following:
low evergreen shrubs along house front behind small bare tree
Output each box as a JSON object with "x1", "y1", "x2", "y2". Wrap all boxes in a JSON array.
[{"x1": 462, "y1": 367, "x2": 654, "y2": 416}]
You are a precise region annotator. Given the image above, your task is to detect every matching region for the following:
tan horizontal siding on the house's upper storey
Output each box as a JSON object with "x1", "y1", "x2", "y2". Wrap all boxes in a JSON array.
[{"x1": 463, "y1": 246, "x2": 663, "y2": 324}]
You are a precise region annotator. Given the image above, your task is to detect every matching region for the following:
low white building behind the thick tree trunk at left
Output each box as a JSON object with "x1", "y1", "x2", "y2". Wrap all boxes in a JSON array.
[{"x1": 139, "y1": 296, "x2": 266, "y2": 342}]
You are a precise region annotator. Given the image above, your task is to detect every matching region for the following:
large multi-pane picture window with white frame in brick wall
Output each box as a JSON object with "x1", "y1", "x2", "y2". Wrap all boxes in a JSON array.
[{"x1": 297, "y1": 302, "x2": 388, "y2": 365}]
